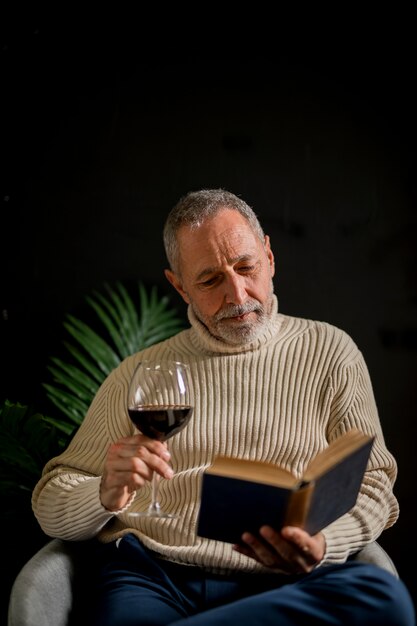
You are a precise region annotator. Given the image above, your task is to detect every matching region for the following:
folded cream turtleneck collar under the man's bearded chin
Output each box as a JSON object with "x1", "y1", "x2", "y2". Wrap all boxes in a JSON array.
[{"x1": 187, "y1": 294, "x2": 281, "y2": 354}]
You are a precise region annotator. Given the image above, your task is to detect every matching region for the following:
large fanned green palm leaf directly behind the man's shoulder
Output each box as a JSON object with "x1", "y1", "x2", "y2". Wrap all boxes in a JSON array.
[{"x1": 43, "y1": 282, "x2": 184, "y2": 436}]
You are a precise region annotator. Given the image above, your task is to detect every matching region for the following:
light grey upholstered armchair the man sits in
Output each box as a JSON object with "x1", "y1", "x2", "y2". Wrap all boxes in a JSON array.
[{"x1": 8, "y1": 539, "x2": 398, "y2": 626}]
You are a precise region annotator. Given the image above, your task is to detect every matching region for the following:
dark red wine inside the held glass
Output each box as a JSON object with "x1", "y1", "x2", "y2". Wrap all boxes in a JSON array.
[{"x1": 128, "y1": 405, "x2": 193, "y2": 441}]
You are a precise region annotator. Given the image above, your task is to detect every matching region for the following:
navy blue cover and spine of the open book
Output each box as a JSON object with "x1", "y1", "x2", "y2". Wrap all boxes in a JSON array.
[{"x1": 197, "y1": 439, "x2": 373, "y2": 543}]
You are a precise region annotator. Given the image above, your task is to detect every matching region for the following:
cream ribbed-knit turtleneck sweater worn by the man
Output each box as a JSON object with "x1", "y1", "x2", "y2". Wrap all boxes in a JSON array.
[{"x1": 33, "y1": 297, "x2": 398, "y2": 572}]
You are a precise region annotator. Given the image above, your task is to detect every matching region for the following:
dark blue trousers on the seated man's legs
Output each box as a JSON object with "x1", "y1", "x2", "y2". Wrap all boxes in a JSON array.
[{"x1": 93, "y1": 535, "x2": 415, "y2": 626}]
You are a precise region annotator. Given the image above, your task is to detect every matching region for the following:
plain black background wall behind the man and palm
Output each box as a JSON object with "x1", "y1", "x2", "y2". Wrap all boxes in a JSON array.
[{"x1": 0, "y1": 15, "x2": 417, "y2": 612}]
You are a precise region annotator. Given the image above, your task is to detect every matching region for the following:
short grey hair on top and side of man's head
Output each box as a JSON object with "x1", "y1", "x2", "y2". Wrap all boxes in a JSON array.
[{"x1": 163, "y1": 189, "x2": 265, "y2": 273}]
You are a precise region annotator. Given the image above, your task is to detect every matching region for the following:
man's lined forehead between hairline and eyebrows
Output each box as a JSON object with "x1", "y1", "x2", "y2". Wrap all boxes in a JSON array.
[{"x1": 178, "y1": 209, "x2": 262, "y2": 274}]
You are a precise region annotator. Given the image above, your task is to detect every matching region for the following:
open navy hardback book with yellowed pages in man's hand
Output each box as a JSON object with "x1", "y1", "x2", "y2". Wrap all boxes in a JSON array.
[{"x1": 197, "y1": 429, "x2": 374, "y2": 543}]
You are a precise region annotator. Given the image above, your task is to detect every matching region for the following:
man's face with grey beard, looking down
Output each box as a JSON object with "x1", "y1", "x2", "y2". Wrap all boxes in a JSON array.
[{"x1": 165, "y1": 209, "x2": 274, "y2": 345}]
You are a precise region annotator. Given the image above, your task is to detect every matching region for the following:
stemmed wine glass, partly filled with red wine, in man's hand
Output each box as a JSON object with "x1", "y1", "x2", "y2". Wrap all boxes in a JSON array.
[{"x1": 127, "y1": 360, "x2": 193, "y2": 517}]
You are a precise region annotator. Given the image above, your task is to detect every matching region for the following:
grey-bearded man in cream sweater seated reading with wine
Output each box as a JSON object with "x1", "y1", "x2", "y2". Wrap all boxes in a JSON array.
[{"x1": 33, "y1": 189, "x2": 414, "y2": 626}]
